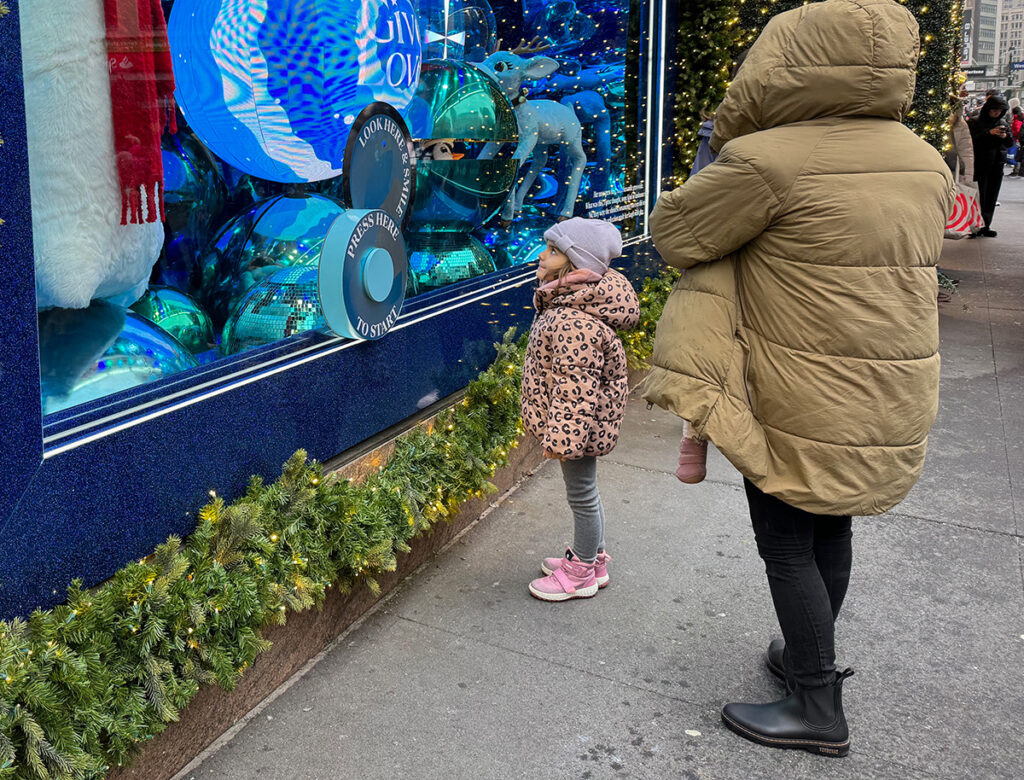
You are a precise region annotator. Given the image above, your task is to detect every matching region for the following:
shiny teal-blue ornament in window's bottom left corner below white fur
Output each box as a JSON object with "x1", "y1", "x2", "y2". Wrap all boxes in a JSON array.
[{"x1": 39, "y1": 301, "x2": 199, "y2": 415}]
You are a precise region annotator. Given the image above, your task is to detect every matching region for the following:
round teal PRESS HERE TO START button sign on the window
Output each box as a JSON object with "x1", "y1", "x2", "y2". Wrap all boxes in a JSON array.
[{"x1": 318, "y1": 209, "x2": 409, "y2": 339}]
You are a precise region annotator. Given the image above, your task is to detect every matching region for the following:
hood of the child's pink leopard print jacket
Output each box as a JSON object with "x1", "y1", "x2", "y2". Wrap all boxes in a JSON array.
[{"x1": 534, "y1": 270, "x2": 639, "y2": 331}]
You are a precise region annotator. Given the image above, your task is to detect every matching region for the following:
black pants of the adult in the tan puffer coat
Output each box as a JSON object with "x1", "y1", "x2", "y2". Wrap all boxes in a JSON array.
[{"x1": 743, "y1": 479, "x2": 853, "y2": 688}]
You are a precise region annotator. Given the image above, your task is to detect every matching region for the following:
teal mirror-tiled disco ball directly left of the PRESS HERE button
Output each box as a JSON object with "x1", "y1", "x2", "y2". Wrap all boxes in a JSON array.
[{"x1": 220, "y1": 266, "x2": 327, "y2": 355}]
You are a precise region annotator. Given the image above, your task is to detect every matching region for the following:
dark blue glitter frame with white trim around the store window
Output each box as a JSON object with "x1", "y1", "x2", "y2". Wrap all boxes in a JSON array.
[{"x1": 0, "y1": 0, "x2": 675, "y2": 618}]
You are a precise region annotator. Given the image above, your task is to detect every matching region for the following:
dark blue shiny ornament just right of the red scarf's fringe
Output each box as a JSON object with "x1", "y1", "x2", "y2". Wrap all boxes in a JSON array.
[{"x1": 151, "y1": 130, "x2": 227, "y2": 290}]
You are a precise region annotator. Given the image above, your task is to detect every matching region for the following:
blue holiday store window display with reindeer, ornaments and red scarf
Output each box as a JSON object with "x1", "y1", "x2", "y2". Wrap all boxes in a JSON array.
[{"x1": 22, "y1": 0, "x2": 639, "y2": 414}]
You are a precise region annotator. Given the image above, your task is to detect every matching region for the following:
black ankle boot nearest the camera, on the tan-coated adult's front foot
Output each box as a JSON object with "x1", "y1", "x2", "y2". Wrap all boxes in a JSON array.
[{"x1": 722, "y1": 668, "x2": 853, "y2": 756}]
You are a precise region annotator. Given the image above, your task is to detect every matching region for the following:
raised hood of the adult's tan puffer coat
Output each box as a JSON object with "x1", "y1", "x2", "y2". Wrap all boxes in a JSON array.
[{"x1": 711, "y1": 0, "x2": 921, "y2": 151}]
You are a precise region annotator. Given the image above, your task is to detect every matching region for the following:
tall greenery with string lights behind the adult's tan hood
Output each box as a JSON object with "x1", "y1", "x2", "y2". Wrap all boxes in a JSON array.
[{"x1": 674, "y1": 0, "x2": 964, "y2": 178}]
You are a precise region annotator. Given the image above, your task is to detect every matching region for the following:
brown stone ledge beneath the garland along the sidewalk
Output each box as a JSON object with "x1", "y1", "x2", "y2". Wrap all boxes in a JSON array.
[{"x1": 108, "y1": 435, "x2": 544, "y2": 780}]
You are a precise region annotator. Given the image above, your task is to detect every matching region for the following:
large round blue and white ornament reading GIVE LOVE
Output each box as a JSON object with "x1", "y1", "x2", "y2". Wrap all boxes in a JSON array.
[{"x1": 168, "y1": 0, "x2": 421, "y2": 182}]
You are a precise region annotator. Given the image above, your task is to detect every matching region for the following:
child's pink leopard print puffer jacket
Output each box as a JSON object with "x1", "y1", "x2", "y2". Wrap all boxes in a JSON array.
[{"x1": 520, "y1": 270, "x2": 640, "y2": 460}]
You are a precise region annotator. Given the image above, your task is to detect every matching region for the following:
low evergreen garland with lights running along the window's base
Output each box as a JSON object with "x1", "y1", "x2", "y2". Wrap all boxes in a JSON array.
[{"x1": 0, "y1": 272, "x2": 678, "y2": 779}]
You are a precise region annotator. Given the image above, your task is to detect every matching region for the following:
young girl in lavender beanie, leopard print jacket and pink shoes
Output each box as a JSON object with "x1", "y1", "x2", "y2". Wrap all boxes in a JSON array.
[{"x1": 521, "y1": 217, "x2": 640, "y2": 601}]
